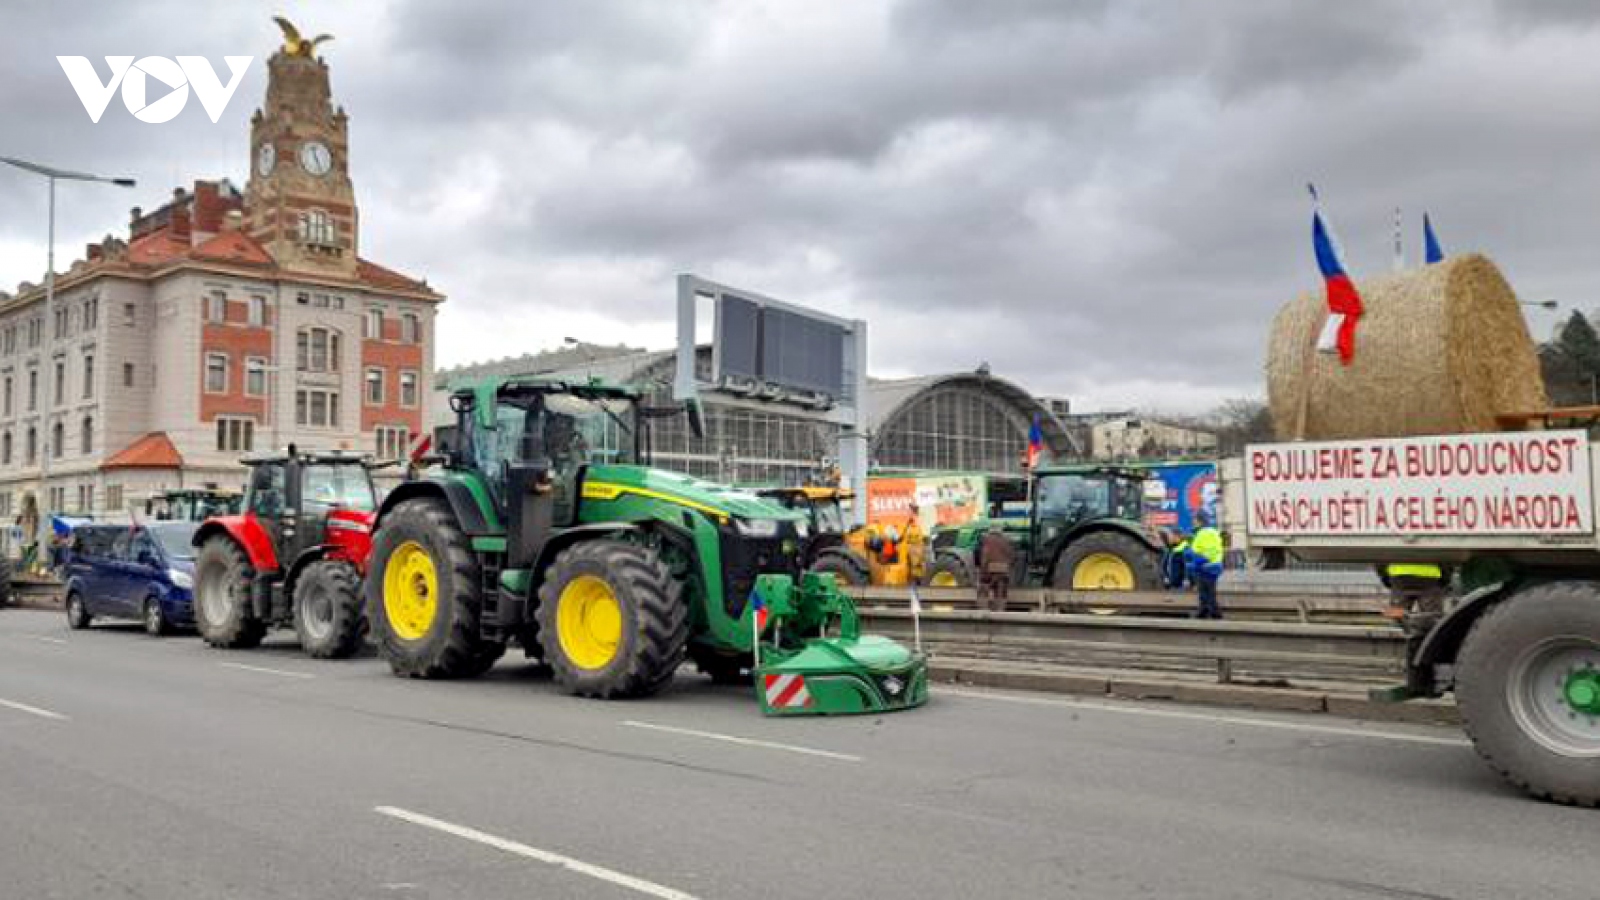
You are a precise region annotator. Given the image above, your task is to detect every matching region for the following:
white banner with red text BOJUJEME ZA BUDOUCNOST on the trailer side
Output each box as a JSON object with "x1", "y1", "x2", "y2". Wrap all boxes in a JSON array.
[{"x1": 1245, "y1": 431, "x2": 1594, "y2": 535}]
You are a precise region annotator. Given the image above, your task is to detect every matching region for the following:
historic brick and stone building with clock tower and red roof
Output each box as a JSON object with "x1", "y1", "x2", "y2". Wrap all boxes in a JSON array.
[{"x1": 0, "y1": 38, "x2": 443, "y2": 516}]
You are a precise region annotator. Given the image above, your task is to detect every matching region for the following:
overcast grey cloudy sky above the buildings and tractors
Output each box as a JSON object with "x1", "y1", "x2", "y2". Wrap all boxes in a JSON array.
[{"x1": 0, "y1": 0, "x2": 1600, "y2": 410}]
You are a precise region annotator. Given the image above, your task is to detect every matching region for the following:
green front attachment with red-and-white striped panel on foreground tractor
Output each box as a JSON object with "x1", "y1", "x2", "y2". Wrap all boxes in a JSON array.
[{"x1": 752, "y1": 573, "x2": 928, "y2": 716}]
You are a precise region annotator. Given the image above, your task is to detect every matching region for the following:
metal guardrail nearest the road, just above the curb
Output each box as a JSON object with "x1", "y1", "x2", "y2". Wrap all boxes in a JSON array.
[{"x1": 861, "y1": 605, "x2": 1406, "y2": 682}]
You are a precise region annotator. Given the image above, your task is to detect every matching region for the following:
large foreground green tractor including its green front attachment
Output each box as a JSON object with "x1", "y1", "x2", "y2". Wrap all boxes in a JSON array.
[{"x1": 366, "y1": 378, "x2": 928, "y2": 714}]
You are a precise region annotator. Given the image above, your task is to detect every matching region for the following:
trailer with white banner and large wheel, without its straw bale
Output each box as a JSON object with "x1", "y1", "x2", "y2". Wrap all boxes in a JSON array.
[{"x1": 1248, "y1": 431, "x2": 1600, "y2": 807}]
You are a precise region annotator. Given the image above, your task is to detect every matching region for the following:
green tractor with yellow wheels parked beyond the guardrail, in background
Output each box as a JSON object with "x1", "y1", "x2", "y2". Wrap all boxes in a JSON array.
[{"x1": 926, "y1": 466, "x2": 1162, "y2": 591}]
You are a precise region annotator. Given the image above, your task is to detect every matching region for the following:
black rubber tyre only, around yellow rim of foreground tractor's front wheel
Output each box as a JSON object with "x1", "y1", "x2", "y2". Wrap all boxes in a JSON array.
[{"x1": 534, "y1": 538, "x2": 690, "y2": 700}]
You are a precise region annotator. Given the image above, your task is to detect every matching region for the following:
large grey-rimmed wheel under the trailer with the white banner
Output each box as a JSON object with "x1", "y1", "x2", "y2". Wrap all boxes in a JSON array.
[{"x1": 1456, "y1": 581, "x2": 1600, "y2": 807}]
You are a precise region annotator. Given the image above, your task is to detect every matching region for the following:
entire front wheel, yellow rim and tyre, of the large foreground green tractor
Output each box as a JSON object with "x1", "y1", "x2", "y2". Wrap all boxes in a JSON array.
[{"x1": 534, "y1": 538, "x2": 690, "y2": 698}]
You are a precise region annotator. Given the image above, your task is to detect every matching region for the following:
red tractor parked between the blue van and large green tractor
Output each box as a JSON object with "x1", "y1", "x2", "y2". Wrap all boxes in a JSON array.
[{"x1": 194, "y1": 444, "x2": 378, "y2": 650}]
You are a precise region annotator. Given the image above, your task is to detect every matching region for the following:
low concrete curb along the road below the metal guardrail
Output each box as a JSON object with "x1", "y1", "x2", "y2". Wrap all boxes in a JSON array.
[{"x1": 928, "y1": 661, "x2": 1461, "y2": 725}]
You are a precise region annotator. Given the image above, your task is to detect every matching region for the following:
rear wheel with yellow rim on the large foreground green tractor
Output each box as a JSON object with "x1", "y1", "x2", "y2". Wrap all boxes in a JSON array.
[{"x1": 366, "y1": 496, "x2": 493, "y2": 677}]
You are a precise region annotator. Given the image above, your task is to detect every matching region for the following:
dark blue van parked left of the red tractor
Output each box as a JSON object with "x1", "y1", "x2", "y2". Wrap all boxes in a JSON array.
[{"x1": 67, "y1": 522, "x2": 200, "y2": 634}]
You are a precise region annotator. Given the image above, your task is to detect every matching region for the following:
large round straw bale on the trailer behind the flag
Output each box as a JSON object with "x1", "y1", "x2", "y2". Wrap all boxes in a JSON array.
[{"x1": 1267, "y1": 253, "x2": 1549, "y2": 440}]
